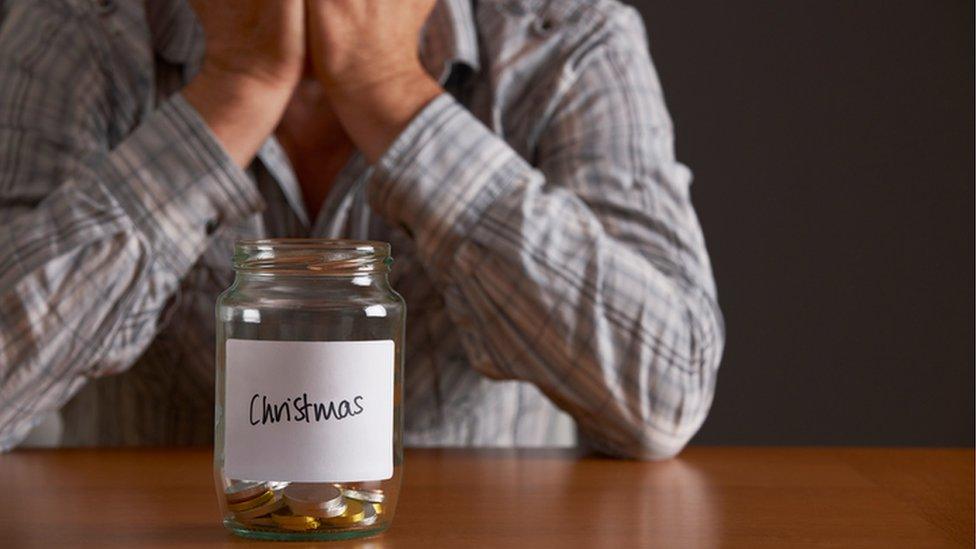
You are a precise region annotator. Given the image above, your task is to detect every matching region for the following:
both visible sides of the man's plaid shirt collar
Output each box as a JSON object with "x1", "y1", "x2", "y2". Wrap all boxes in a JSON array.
[{"x1": 146, "y1": 0, "x2": 480, "y2": 84}]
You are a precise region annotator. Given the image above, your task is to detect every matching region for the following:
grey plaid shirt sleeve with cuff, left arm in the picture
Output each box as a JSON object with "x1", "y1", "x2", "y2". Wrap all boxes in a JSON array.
[{"x1": 0, "y1": 8, "x2": 262, "y2": 450}]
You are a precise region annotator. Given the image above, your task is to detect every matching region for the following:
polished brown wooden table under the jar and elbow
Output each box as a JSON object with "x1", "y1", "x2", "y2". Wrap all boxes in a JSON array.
[{"x1": 0, "y1": 448, "x2": 974, "y2": 549}]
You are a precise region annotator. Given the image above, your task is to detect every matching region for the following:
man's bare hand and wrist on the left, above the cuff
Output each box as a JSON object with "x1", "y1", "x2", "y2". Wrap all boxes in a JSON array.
[{"x1": 183, "y1": 0, "x2": 306, "y2": 167}]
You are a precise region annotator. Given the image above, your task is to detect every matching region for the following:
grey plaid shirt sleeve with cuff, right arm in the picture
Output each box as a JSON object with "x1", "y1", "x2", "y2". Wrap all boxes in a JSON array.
[{"x1": 370, "y1": 9, "x2": 724, "y2": 459}]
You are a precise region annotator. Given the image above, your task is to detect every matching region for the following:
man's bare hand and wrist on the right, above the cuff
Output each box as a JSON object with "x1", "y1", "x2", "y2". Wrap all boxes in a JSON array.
[{"x1": 306, "y1": 0, "x2": 443, "y2": 163}]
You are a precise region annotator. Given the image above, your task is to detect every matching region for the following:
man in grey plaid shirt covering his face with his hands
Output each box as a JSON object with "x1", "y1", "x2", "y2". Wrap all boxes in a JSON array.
[{"x1": 0, "y1": 0, "x2": 724, "y2": 458}]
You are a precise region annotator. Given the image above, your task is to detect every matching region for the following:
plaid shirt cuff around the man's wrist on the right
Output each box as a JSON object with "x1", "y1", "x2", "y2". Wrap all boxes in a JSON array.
[{"x1": 369, "y1": 93, "x2": 532, "y2": 269}]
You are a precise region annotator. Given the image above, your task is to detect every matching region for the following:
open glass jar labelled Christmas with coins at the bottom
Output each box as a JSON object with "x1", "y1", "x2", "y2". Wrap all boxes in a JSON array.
[{"x1": 214, "y1": 239, "x2": 406, "y2": 540}]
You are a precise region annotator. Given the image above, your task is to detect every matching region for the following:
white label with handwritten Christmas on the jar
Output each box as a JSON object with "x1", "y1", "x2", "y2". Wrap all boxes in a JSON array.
[{"x1": 224, "y1": 339, "x2": 394, "y2": 482}]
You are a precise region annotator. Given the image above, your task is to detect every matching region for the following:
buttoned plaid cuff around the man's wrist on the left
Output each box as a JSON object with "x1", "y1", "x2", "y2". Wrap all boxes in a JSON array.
[{"x1": 95, "y1": 94, "x2": 264, "y2": 272}]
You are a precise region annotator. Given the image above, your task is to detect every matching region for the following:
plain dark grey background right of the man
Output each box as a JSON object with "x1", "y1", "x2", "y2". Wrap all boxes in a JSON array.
[{"x1": 632, "y1": 0, "x2": 974, "y2": 445}]
